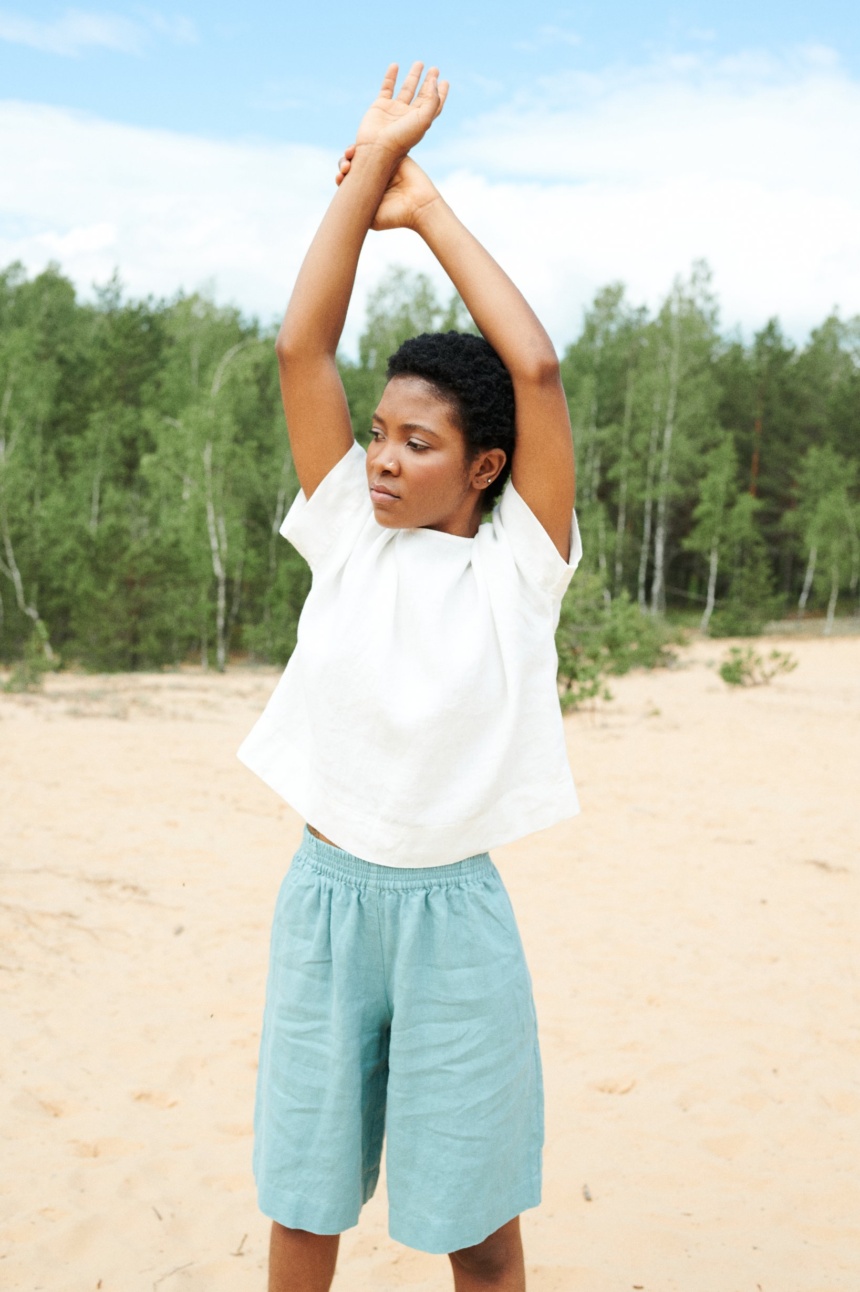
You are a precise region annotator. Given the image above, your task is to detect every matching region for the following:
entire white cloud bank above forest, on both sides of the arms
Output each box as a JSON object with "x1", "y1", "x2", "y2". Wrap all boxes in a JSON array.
[{"x1": 0, "y1": 44, "x2": 860, "y2": 349}]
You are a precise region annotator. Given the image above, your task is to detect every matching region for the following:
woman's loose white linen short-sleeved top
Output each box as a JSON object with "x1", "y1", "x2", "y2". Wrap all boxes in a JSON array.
[{"x1": 239, "y1": 443, "x2": 582, "y2": 867}]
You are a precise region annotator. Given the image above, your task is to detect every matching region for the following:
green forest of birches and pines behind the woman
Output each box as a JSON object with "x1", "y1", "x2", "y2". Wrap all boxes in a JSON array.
[{"x1": 0, "y1": 264, "x2": 860, "y2": 678}]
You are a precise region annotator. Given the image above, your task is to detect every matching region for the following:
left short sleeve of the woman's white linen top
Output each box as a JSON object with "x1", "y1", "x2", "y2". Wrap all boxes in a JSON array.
[{"x1": 280, "y1": 443, "x2": 373, "y2": 572}]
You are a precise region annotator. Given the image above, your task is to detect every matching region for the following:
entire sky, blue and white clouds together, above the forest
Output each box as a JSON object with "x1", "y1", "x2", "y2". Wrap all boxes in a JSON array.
[{"x1": 0, "y1": 0, "x2": 860, "y2": 350}]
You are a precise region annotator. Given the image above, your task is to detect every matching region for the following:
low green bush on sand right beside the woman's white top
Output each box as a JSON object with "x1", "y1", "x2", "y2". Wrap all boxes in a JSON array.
[{"x1": 555, "y1": 571, "x2": 679, "y2": 709}]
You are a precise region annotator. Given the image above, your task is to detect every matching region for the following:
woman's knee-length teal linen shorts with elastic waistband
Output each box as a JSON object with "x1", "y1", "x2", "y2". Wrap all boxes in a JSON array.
[{"x1": 253, "y1": 829, "x2": 544, "y2": 1252}]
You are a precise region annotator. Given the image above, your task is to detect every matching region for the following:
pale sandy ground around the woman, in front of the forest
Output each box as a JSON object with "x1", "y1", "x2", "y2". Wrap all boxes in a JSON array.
[{"x1": 0, "y1": 638, "x2": 860, "y2": 1292}]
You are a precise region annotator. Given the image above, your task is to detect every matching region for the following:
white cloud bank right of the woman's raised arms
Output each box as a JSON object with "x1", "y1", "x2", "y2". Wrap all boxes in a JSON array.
[{"x1": 427, "y1": 48, "x2": 860, "y2": 337}]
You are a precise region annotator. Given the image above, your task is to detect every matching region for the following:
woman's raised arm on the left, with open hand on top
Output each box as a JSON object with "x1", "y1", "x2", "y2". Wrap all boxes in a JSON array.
[{"x1": 275, "y1": 63, "x2": 448, "y2": 497}]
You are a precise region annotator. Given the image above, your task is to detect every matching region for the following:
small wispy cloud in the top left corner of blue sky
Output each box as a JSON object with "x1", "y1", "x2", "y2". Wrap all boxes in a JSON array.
[{"x1": 0, "y1": 9, "x2": 196, "y2": 58}]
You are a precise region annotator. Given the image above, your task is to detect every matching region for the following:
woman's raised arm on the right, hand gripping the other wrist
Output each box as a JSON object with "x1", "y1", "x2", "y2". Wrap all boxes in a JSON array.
[{"x1": 337, "y1": 147, "x2": 575, "y2": 561}]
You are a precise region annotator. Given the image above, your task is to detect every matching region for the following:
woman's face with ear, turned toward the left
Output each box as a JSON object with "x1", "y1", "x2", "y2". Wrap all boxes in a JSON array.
[{"x1": 367, "y1": 376, "x2": 505, "y2": 536}]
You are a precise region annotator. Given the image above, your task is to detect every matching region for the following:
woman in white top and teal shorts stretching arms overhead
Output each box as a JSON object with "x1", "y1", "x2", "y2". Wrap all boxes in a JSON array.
[{"x1": 239, "y1": 63, "x2": 580, "y2": 1292}]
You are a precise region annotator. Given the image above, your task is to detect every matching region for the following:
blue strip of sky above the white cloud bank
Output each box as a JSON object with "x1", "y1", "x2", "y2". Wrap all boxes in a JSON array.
[{"x1": 0, "y1": 0, "x2": 860, "y2": 149}]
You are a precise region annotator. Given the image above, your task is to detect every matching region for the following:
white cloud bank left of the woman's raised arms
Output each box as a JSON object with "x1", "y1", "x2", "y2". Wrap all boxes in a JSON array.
[{"x1": 0, "y1": 102, "x2": 337, "y2": 328}]
